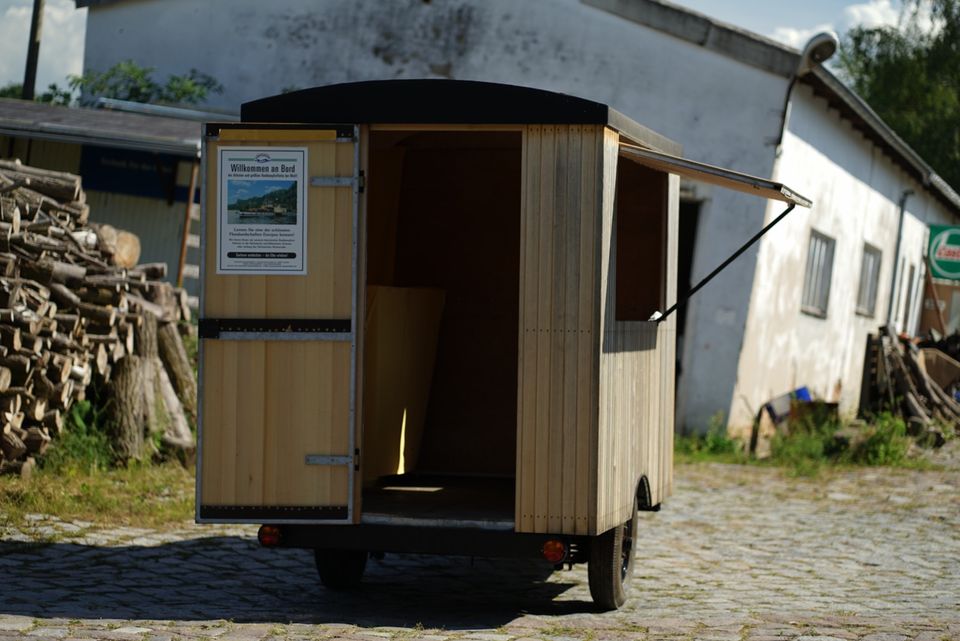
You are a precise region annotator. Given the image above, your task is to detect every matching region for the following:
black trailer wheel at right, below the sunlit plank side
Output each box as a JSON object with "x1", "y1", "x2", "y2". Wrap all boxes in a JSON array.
[{"x1": 587, "y1": 502, "x2": 638, "y2": 610}]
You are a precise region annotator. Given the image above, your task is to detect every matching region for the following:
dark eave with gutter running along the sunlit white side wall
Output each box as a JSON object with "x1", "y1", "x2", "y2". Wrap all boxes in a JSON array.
[{"x1": 800, "y1": 67, "x2": 960, "y2": 215}]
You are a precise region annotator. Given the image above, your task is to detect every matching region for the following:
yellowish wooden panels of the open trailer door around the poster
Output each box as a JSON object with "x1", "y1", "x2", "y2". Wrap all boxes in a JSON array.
[{"x1": 201, "y1": 134, "x2": 353, "y2": 506}]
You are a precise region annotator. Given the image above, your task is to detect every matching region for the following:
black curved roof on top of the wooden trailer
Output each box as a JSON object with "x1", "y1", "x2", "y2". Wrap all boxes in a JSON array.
[{"x1": 235, "y1": 79, "x2": 680, "y2": 153}]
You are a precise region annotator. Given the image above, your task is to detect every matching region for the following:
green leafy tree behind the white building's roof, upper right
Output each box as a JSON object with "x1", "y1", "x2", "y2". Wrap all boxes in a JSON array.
[{"x1": 838, "y1": 0, "x2": 960, "y2": 190}]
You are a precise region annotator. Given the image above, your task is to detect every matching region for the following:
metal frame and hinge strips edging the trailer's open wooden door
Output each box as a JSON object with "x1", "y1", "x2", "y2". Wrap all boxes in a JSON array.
[{"x1": 195, "y1": 125, "x2": 361, "y2": 525}]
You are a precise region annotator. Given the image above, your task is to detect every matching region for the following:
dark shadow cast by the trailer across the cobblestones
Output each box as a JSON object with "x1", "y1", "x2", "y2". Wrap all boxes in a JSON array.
[{"x1": 0, "y1": 537, "x2": 593, "y2": 630}]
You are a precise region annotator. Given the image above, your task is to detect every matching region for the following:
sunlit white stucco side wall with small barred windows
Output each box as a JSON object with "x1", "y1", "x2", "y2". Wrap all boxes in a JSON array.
[{"x1": 730, "y1": 81, "x2": 955, "y2": 429}]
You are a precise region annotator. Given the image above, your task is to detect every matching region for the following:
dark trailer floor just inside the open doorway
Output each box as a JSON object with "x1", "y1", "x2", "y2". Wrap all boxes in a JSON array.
[{"x1": 361, "y1": 474, "x2": 516, "y2": 530}]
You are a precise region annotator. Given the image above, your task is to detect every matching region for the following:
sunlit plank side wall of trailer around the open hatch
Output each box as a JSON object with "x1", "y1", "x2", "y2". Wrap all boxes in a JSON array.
[{"x1": 596, "y1": 130, "x2": 679, "y2": 532}]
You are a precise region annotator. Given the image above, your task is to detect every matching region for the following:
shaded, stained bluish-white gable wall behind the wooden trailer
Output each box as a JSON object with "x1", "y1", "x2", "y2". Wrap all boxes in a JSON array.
[{"x1": 84, "y1": 0, "x2": 794, "y2": 429}]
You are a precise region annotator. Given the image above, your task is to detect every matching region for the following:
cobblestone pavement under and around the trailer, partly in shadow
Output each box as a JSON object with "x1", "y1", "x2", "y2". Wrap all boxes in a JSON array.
[{"x1": 0, "y1": 456, "x2": 960, "y2": 641}]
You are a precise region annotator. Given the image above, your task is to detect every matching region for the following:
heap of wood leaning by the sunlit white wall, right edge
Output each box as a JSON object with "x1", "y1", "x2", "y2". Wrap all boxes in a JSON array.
[{"x1": 863, "y1": 326, "x2": 960, "y2": 447}]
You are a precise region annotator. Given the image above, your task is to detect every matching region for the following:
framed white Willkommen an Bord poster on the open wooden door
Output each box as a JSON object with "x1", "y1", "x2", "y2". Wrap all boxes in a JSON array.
[{"x1": 217, "y1": 147, "x2": 307, "y2": 276}]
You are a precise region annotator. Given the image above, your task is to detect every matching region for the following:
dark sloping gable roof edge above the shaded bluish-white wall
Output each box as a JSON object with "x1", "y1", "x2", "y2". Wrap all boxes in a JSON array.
[{"x1": 580, "y1": 0, "x2": 800, "y2": 78}]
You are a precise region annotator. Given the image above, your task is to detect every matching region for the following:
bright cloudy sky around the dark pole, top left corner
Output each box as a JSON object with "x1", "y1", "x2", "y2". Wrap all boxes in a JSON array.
[{"x1": 0, "y1": 0, "x2": 87, "y2": 92}]
